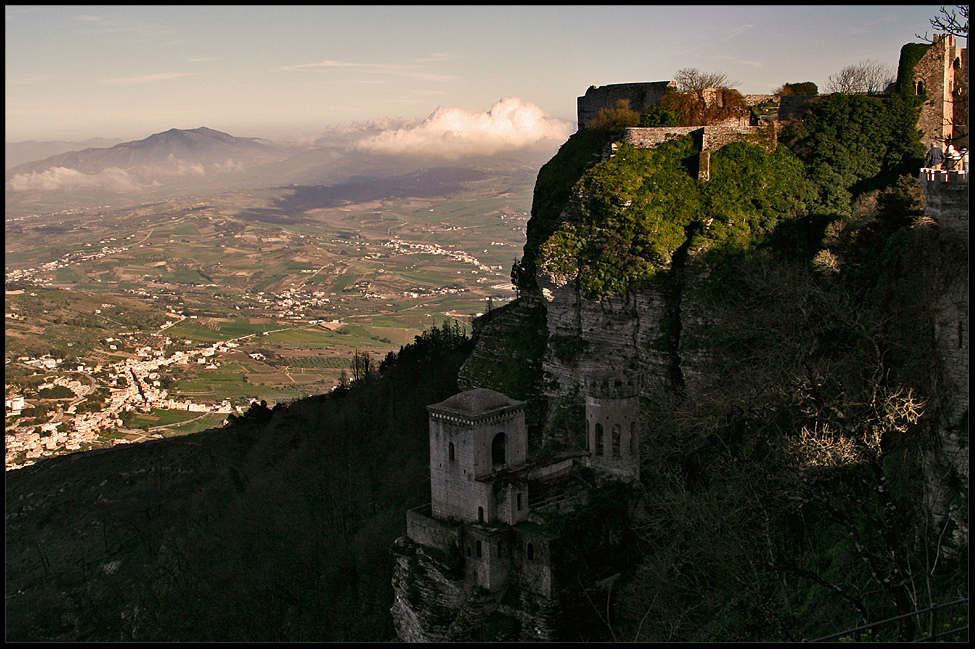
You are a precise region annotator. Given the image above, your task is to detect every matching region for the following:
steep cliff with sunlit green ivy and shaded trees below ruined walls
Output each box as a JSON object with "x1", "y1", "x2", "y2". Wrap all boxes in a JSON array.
[{"x1": 462, "y1": 90, "x2": 968, "y2": 640}]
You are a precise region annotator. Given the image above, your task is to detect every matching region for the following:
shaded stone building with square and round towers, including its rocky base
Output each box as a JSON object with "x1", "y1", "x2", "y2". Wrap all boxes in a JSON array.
[{"x1": 391, "y1": 375, "x2": 640, "y2": 641}]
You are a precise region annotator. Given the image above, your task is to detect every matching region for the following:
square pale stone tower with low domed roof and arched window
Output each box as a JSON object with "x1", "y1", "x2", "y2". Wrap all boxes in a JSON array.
[{"x1": 427, "y1": 388, "x2": 528, "y2": 524}]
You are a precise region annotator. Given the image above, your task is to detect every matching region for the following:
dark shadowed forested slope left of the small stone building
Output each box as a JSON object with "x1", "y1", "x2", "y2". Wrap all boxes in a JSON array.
[{"x1": 5, "y1": 324, "x2": 472, "y2": 641}]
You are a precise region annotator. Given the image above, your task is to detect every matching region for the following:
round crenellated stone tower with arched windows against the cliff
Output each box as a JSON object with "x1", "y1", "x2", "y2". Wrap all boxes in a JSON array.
[{"x1": 586, "y1": 373, "x2": 640, "y2": 480}]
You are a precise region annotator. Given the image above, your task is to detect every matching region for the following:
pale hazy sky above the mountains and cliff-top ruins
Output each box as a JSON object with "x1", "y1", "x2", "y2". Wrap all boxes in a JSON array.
[{"x1": 5, "y1": 5, "x2": 956, "y2": 142}]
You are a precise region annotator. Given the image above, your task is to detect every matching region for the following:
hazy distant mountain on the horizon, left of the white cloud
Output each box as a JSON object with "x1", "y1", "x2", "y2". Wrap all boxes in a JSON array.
[{"x1": 6, "y1": 127, "x2": 294, "y2": 179}]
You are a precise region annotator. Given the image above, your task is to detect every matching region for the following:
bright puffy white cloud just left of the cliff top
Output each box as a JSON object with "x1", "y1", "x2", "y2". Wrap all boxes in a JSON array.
[{"x1": 357, "y1": 97, "x2": 575, "y2": 158}]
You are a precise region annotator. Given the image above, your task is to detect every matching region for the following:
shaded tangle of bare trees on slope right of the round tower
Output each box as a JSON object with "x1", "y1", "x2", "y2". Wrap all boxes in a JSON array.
[{"x1": 620, "y1": 180, "x2": 967, "y2": 641}]
